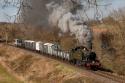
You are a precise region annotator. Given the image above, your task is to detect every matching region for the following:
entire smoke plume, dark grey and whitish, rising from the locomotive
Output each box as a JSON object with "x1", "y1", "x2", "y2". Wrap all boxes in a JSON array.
[{"x1": 20, "y1": 0, "x2": 93, "y2": 48}]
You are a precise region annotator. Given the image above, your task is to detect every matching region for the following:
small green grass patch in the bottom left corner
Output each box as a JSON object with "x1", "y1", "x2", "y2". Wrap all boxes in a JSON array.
[{"x1": 0, "y1": 64, "x2": 23, "y2": 83}]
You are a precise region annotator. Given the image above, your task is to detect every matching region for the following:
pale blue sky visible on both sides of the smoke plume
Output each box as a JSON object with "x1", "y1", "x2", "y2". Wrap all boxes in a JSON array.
[{"x1": 0, "y1": 0, "x2": 125, "y2": 22}]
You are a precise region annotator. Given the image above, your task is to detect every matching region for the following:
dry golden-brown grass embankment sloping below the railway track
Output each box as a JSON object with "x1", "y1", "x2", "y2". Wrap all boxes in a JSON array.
[{"x1": 0, "y1": 45, "x2": 101, "y2": 83}]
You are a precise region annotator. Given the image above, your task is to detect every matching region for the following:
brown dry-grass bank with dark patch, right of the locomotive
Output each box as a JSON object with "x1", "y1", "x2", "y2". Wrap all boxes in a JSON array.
[{"x1": 93, "y1": 21, "x2": 125, "y2": 75}]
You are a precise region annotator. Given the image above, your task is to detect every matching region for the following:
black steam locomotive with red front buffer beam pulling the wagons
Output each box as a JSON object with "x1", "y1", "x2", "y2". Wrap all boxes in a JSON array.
[{"x1": 71, "y1": 46, "x2": 101, "y2": 70}]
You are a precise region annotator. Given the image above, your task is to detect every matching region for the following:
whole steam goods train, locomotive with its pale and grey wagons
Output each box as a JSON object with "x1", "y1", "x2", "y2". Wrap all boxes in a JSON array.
[{"x1": 14, "y1": 39, "x2": 101, "y2": 70}]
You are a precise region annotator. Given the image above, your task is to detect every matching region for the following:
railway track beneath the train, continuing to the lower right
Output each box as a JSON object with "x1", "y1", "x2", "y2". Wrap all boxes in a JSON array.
[{"x1": 6, "y1": 44, "x2": 125, "y2": 83}]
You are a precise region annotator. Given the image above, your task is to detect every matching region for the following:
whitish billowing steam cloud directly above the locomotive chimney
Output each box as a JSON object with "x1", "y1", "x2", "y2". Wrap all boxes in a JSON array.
[{"x1": 46, "y1": 0, "x2": 92, "y2": 48}]
